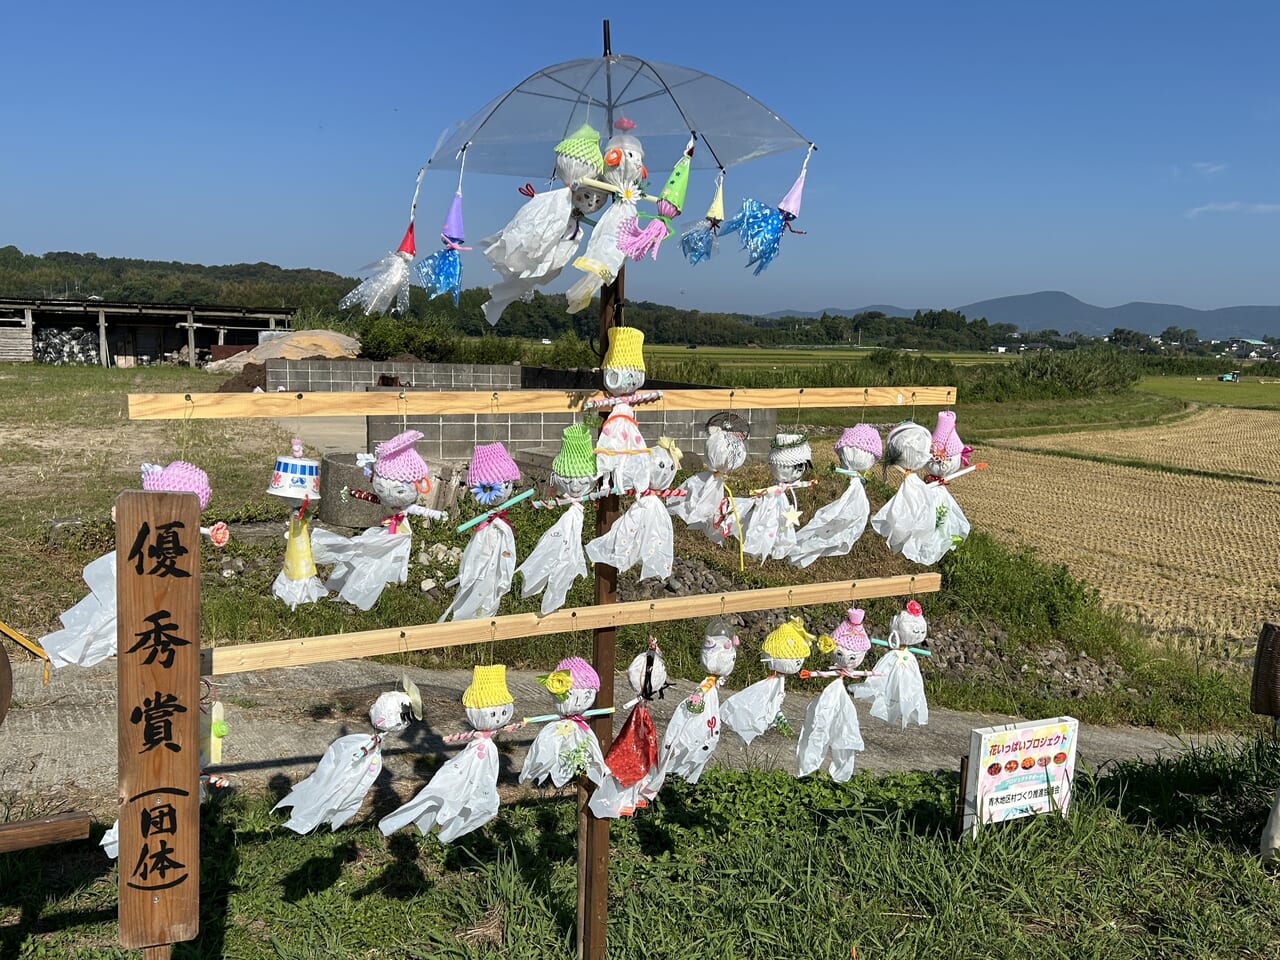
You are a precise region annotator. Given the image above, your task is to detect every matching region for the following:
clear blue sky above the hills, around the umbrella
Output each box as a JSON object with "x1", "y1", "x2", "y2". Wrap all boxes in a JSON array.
[{"x1": 0, "y1": 1, "x2": 1280, "y2": 312}]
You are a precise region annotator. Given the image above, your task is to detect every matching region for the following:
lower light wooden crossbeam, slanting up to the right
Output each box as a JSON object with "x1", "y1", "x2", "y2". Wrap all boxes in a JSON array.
[{"x1": 200, "y1": 573, "x2": 942, "y2": 676}]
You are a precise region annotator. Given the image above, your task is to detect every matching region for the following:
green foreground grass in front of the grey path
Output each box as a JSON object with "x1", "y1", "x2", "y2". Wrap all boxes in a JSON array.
[{"x1": 0, "y1": 739, "x2": 1280, "y2": 960}]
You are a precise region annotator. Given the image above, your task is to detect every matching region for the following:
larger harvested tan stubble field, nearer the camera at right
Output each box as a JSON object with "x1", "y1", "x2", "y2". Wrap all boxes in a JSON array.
[{"x1": 955, "y1": 445, "x2": 1280, "y2": 640}]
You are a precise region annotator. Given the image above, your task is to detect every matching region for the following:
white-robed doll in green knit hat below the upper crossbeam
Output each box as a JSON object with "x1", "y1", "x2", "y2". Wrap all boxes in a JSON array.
[{"x1": 516, "y1": 424, "x2": 595, "y2": 616}]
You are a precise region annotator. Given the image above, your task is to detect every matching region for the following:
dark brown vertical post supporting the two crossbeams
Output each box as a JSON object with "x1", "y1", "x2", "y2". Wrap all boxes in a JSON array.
[{"x1": 577, "y1": 266, "x2": 626, "y2": 960}]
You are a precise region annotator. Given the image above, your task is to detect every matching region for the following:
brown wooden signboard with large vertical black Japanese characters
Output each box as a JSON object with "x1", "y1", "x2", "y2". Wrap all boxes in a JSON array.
[{"x1": 115, "y1": 492, "x2": 200, "y2": 960}]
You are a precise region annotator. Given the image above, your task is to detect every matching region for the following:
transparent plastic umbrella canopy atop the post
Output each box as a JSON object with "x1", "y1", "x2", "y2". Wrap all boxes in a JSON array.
[{"x1": 428, "y1": 54, "x2": 810, "y2": 177}]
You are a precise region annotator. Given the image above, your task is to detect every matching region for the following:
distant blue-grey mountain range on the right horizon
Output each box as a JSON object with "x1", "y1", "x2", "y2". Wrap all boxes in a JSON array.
[{"x1": 768, "y1": 291, "x2": 1280, "y2": 340}]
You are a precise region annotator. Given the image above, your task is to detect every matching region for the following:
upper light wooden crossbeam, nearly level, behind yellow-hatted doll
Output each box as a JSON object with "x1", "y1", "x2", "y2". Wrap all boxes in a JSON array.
[{"x1": 129, "y1": 387, "x2": 956, "y2": 420}]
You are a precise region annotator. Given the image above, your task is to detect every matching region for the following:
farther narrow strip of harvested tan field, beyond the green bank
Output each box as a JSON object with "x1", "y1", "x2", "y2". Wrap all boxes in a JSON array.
[{"x1": 998, "y1": 407, "x2": 1280, "y2": 483}]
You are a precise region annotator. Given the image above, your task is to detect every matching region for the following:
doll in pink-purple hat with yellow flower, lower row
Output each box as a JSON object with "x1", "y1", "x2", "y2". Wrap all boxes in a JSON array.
[{"x1": 520, "y1": 657, "x2": 609, "y2": 787}]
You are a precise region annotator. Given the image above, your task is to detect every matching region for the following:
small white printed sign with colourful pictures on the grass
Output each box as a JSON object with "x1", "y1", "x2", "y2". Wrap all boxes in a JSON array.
[{"x1": 964, "y1": 717, "x2": 1080, "y2": 836}]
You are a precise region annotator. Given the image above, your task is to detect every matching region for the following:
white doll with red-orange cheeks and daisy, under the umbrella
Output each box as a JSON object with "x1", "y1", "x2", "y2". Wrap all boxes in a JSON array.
[{"x1": 566, "y1": 116, "x2": 649, "y2": 314}]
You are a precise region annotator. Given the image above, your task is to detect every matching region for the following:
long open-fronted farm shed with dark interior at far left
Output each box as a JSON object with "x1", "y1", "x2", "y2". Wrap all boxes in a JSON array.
[{"x1": 0, "y1": 298, "x2": 294, "y2": 367}]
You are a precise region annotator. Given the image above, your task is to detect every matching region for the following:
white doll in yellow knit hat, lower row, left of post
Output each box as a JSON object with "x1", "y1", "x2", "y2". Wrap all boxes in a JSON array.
[{"x1": 378, "y1": 663, "x2": 516, "y2": 844}]
